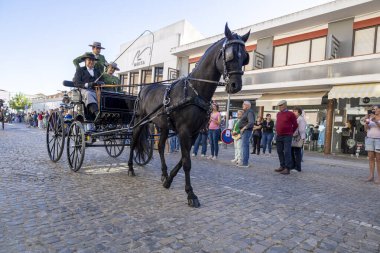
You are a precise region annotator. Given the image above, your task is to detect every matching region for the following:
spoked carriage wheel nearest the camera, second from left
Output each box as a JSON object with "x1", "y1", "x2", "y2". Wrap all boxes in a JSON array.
[{"x1": 66, "y1": 121, "x2": 86, "y2": 172}]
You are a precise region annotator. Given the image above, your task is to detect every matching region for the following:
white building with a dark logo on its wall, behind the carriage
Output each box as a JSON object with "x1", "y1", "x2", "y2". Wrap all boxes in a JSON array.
[{"x1": 117, "y1": 20, "x2": 204, "y2": 95}]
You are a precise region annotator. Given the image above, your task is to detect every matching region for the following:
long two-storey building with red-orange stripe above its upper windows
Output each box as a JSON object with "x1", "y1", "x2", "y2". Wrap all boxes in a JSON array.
[{"x1": 171, "y1": 0, "x2": 380, "y2": 154}]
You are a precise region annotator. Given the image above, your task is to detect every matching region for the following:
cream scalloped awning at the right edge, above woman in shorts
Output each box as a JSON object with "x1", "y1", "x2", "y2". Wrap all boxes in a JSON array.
[{"x1": 329, "y1": 83, "x2": 380, "y2": 99}]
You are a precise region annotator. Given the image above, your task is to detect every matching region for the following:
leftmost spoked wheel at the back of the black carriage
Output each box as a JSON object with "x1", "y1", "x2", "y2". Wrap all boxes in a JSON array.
[{"x1": 46, "y1": 112, "x2": 65, "y2": 162}]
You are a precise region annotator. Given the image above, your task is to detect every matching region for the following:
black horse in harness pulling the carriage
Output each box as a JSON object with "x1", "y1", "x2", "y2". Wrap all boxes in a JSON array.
[{"x1": 128, "y1": 24, "x2": 250, "y2": 207}]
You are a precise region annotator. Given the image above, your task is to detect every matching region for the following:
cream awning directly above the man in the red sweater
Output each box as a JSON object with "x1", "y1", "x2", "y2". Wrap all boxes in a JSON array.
[{"x1": 256, "y1": 91, "x2": 326, "y2": 107}]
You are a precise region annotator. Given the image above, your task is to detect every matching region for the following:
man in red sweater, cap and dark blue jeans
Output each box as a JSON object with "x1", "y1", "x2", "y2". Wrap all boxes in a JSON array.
[{"x1": 275, "y1": 100, "x2": 298, "y2": 175}]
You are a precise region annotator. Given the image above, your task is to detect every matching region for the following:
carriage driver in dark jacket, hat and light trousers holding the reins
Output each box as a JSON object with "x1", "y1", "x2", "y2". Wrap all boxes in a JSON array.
[{"x1": 73, "y1": 53, "x2": 104, "y2": 120}]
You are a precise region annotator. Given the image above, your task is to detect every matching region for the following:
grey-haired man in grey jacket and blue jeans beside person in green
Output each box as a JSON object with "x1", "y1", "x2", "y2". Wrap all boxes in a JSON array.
[{"x1": 238, "y1": 101, "x2": 255, "y2": 168}]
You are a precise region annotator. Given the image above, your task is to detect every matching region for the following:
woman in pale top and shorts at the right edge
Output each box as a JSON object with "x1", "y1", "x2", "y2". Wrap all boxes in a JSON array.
[{"x1": 365, "y1": 105, "x2": 380, "y2": 184}]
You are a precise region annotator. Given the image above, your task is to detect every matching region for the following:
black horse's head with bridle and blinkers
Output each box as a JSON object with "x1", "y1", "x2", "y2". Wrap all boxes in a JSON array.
[{"x1": 216, "y1": 24, "x2": 250, "y2": 93}]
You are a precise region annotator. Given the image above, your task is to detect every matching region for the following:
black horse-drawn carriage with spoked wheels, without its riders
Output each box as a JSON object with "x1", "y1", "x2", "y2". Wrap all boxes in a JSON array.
[{"x1": 46, "y1": 81, "x2": 154, "y2": 171}]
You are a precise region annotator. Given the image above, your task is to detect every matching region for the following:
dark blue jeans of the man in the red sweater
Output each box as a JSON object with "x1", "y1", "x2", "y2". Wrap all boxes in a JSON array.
[{"x1": 276, "y1": 135, "x2": 293, "y2": 170}]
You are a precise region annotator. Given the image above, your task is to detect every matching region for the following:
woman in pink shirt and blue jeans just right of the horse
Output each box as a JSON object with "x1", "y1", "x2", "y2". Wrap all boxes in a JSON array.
[{"x1": 208, "y1": 103, "x2": 221, "y2": 160}]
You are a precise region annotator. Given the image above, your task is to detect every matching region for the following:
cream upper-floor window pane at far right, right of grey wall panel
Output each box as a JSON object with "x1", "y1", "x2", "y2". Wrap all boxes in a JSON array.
[{"x1": 354, "y1": 27, "x2": 376, "y2": 56}]
